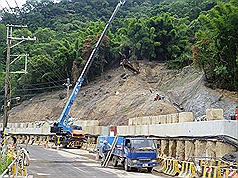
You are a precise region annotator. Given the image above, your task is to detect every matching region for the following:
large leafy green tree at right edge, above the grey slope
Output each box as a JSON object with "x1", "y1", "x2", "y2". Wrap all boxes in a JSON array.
[{"x1": 195, "y1": 3, "x2": 238, "y2": 90}]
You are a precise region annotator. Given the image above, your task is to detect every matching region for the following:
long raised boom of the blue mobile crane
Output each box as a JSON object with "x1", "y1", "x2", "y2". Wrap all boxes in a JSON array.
[{"x1": 51, "y1": 0, "x2": 126, "y2": 133}]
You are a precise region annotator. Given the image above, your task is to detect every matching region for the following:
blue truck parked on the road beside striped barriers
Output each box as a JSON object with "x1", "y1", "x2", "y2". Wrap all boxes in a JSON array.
[{"x1": 97, "y1": 136, "x2": 158, "y2": 172}]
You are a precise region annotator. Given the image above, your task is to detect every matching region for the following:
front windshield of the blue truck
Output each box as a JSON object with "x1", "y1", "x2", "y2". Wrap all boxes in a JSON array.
[{"x1": 131, "y1": 139, "x2": 156, "y2": 150}]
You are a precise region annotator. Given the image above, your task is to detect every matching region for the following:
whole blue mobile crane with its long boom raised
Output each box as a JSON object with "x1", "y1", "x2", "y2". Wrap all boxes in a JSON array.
[{"x1": 50, "y1": 0, "x2": 126, "y2": 148}]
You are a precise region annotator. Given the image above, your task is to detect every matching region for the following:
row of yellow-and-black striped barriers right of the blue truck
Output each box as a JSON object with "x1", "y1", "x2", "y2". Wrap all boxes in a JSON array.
[{"x1": 156, "y1": 154, "x2": 238, "y2": 178}]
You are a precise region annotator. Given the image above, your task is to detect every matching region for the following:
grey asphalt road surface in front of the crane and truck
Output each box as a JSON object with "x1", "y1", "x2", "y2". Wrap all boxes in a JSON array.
[{"x1": 24, "y1": 146, "x2": 165, "y2": 178}]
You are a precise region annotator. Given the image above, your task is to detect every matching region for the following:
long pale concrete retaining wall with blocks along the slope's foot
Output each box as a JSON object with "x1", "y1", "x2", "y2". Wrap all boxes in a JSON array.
[{"x1": 0, "y1": 109, "x2": 238, "y2": 160}]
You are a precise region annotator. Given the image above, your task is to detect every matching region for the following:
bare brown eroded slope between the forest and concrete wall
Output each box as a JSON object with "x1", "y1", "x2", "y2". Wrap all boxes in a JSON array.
[{"x1": 3, "y1": 61, "x2": 238, "y2": 125}]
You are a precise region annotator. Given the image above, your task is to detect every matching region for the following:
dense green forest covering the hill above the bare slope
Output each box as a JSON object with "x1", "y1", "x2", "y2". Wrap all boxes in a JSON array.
[{"x1": 0, "y1": 0, "x2": 238, "y2": 107}]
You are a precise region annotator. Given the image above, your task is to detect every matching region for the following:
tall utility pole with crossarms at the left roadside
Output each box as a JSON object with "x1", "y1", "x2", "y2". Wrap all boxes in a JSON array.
[{"x1": 3, "y1": 24, "x2": 36, "y2": 132}]
